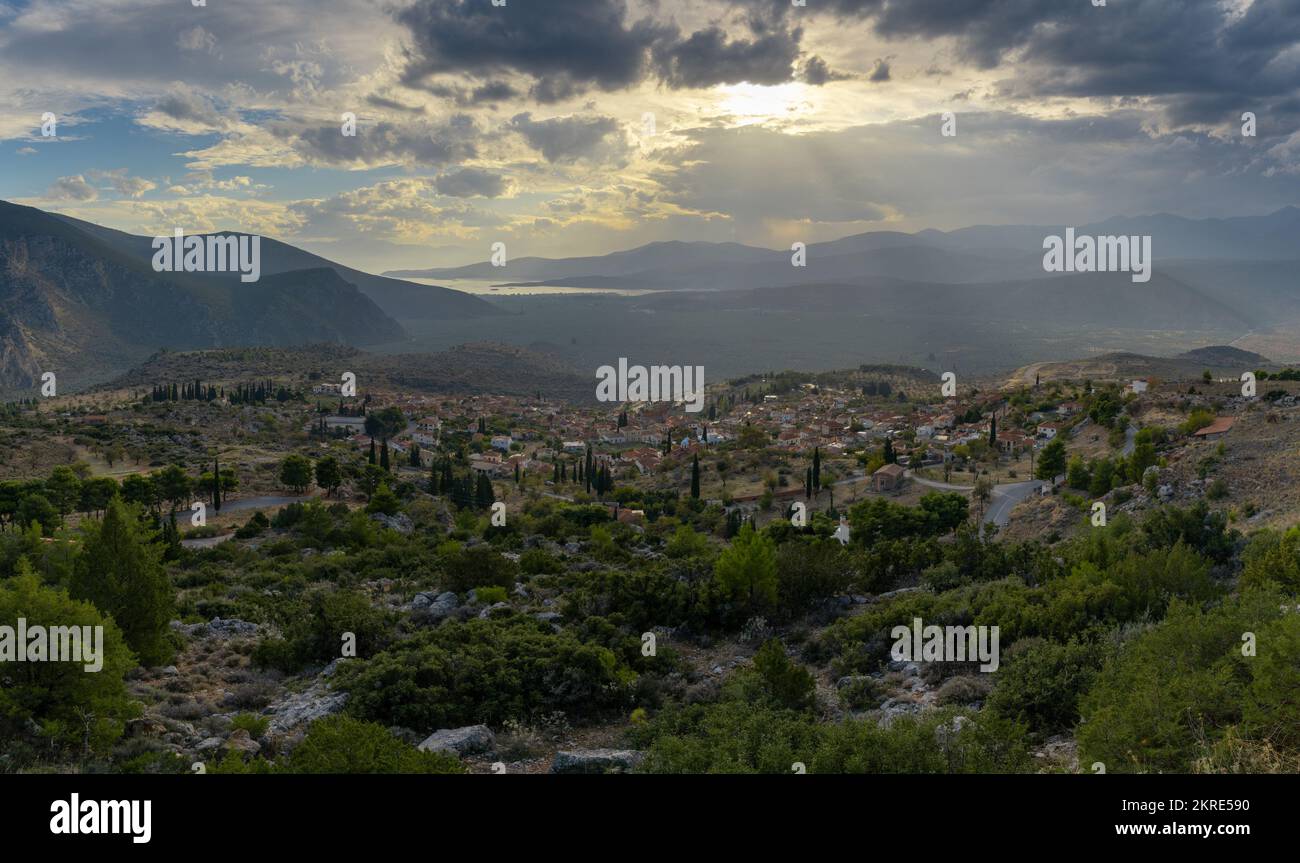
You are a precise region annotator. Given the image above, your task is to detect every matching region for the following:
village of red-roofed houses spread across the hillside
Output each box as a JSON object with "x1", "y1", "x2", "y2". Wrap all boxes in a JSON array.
[{"x1": 299, "y1": 366, "x2": 1190, "y2": 524}]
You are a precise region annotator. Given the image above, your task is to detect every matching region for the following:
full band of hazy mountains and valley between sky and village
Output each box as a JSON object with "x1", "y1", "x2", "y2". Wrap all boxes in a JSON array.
[{"x1": 0, "y1": 201, "x2": 1300, "y2": 395}]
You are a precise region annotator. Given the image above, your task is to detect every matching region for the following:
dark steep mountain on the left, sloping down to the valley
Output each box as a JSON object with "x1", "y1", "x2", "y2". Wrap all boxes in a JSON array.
[{"x1": 0, "y1": 201, "x2": 502, "y2": 393}]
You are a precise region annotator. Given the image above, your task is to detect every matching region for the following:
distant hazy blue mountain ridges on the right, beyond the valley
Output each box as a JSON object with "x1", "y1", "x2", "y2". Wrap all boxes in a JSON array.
[{"x1": 387, "y1": 207, "x2": 1300, "y2": 330}]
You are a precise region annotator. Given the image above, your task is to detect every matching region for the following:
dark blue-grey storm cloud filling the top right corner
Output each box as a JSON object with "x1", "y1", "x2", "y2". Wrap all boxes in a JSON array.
[{"x1": 738, "y1": 0, "x2": 1300, "y2": 125}]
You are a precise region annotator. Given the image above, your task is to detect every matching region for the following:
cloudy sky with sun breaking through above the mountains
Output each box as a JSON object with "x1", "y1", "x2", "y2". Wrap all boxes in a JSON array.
[{"x1": 0, "y1": 0, "x2": 1300, "y2": 272}]
